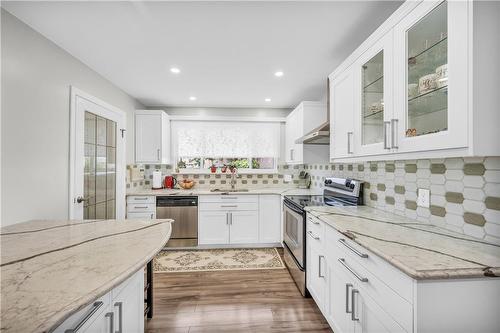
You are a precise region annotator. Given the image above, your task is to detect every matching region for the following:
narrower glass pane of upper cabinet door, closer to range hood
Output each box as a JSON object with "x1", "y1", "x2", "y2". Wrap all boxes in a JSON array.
[{"x1": 361, "y1": 50, "x2": 384, "y2": 145}]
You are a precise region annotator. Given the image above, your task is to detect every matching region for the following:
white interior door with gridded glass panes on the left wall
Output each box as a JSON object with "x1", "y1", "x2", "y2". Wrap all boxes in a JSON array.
[{"x1": 69, "y1": 88, "x2": 126, "y2": 220}]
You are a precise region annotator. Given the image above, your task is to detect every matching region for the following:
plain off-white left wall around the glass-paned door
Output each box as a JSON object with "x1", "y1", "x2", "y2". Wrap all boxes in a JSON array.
[{"x1": 1, "y1": 9, "x2": 143, "y2": 225}]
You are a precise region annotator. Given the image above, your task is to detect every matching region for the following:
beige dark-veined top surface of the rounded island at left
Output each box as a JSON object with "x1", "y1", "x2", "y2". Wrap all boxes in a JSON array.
[{"x1": 0, "y1": 220, "x2": 172, "y2": 333}]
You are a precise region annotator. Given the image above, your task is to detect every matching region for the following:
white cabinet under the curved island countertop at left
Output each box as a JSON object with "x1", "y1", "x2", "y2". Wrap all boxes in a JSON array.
[{"x1": 54, "y1": 269, "x2": 144, "y2": 333}]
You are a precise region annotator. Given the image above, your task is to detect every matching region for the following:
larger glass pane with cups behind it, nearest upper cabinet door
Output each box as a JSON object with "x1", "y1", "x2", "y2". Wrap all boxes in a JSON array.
[{"x1": 405, "y1": 1, "x2": 448, "y2": 137}]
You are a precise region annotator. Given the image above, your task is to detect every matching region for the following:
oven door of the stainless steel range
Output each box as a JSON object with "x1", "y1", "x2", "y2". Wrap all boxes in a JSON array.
[{"x1": 283, "y1": 201, "x2": 305, "y2": 270}]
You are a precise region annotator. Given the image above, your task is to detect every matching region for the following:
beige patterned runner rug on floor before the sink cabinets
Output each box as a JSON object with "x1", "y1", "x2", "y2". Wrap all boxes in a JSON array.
[{"x1": 153, "y1": 248, "x2": 285, "y2": 272}]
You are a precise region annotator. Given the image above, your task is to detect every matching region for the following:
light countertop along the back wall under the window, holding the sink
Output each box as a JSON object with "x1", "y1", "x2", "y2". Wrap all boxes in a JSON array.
[{"x1": 127, "y1": 186, "x2": 323, "y2": 196}]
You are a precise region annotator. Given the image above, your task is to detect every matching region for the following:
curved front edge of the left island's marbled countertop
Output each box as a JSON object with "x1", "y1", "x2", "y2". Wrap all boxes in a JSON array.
[{"x1": 45, "y1": 222, "x2": 172, "y2": 332}]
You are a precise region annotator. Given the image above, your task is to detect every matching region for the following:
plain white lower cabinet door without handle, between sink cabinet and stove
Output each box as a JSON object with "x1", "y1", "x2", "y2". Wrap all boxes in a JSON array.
[{"x1": 259, "y1": 194, "x2": 282, "y2": 244}]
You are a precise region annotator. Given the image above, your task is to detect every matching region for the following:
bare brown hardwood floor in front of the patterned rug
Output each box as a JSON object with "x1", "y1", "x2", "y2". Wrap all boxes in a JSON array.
[{"x1": 146, "y1": 269, "x2": 332, "y2": 333}]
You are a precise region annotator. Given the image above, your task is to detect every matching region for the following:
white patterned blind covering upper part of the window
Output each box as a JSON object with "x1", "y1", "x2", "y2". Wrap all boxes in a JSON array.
[{"x1": 171, "y1": 121, "x2": 280, "y2": 158}]
